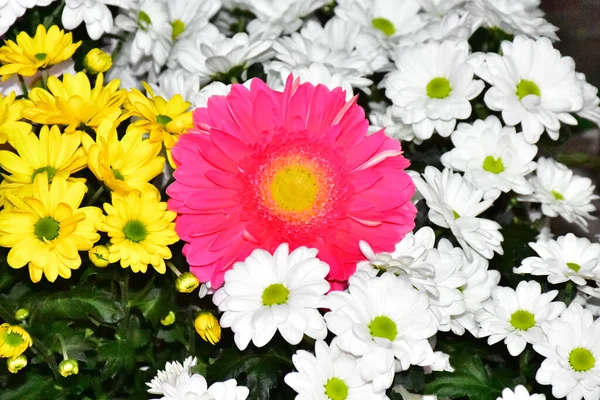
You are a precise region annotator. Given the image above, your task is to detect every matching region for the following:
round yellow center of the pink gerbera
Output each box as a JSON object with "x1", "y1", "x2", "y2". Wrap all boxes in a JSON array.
[{"x1": 271, "y1": 165, "x2": 319, "y2": 212}]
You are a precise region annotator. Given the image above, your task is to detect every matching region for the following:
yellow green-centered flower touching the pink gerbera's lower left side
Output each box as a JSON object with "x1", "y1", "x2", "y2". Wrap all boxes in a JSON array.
[{"x1": 99, "y1": 190, "x2": 179, "y2": 274}]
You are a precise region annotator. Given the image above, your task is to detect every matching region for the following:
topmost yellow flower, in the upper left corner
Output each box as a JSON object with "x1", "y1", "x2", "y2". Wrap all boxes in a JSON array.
[{"x1": 0, "y1": 25, "x2": 81, "y2": 81}]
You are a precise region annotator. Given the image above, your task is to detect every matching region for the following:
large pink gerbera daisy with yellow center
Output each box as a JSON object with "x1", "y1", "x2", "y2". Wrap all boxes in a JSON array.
[{"x1": 167, "y1": 79, "x2": 416, "y2": 288}]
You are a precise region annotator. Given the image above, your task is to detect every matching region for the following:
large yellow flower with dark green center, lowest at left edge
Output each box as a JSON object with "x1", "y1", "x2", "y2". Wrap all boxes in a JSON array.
[{"x1": 0, "y1": 172, "x2": 102, "y2": 282}]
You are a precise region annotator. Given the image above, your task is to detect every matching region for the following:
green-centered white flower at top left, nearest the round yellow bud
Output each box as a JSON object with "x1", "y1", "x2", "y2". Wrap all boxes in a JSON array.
[{"x1": 115, "y1": 0, "x2": 173, "y2": 73}]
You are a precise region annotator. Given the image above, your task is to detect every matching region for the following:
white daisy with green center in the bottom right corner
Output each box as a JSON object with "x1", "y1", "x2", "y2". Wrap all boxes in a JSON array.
[{"x1": 533, "y1": 304, "x2": 600, "y2": 400}]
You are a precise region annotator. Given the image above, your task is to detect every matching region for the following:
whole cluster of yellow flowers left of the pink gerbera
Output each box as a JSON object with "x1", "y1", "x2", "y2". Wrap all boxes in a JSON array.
[{"x1": 0, "y1": 25, "x2": 192, "y2": 282}]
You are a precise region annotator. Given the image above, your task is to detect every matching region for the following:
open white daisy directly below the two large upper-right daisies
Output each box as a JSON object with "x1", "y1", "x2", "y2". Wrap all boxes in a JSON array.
[{"x1": 441, "y1": 115, "x2": 537, "y2": 198}]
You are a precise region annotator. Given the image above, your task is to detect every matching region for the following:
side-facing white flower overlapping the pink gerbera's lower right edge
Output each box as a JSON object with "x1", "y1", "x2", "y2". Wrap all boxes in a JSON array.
[{"x1": 357, "y1": 226, "x2": 439, "y2": 296}]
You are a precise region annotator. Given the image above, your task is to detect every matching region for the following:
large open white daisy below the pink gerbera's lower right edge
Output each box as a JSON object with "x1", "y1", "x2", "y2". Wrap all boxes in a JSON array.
[{"x1": 325, "y1": 272, "x2": 438, "y2": 392}]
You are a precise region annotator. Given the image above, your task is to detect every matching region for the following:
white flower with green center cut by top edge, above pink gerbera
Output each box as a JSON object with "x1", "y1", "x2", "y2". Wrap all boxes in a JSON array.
[{"x1": 334, "y1": 0, "x2": 425, "y2": 42}]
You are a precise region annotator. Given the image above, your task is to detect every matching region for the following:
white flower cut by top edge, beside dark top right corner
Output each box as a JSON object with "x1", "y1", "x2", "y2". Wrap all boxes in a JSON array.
[{"x1": 466, "y1": 0, "x2": 558, "y2": 41}]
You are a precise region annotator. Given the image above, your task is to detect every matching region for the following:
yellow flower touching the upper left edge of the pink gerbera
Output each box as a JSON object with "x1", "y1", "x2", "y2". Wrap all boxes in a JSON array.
[{"x1": 124, "y1": 82, "x2": 194, "y2": 150}]
